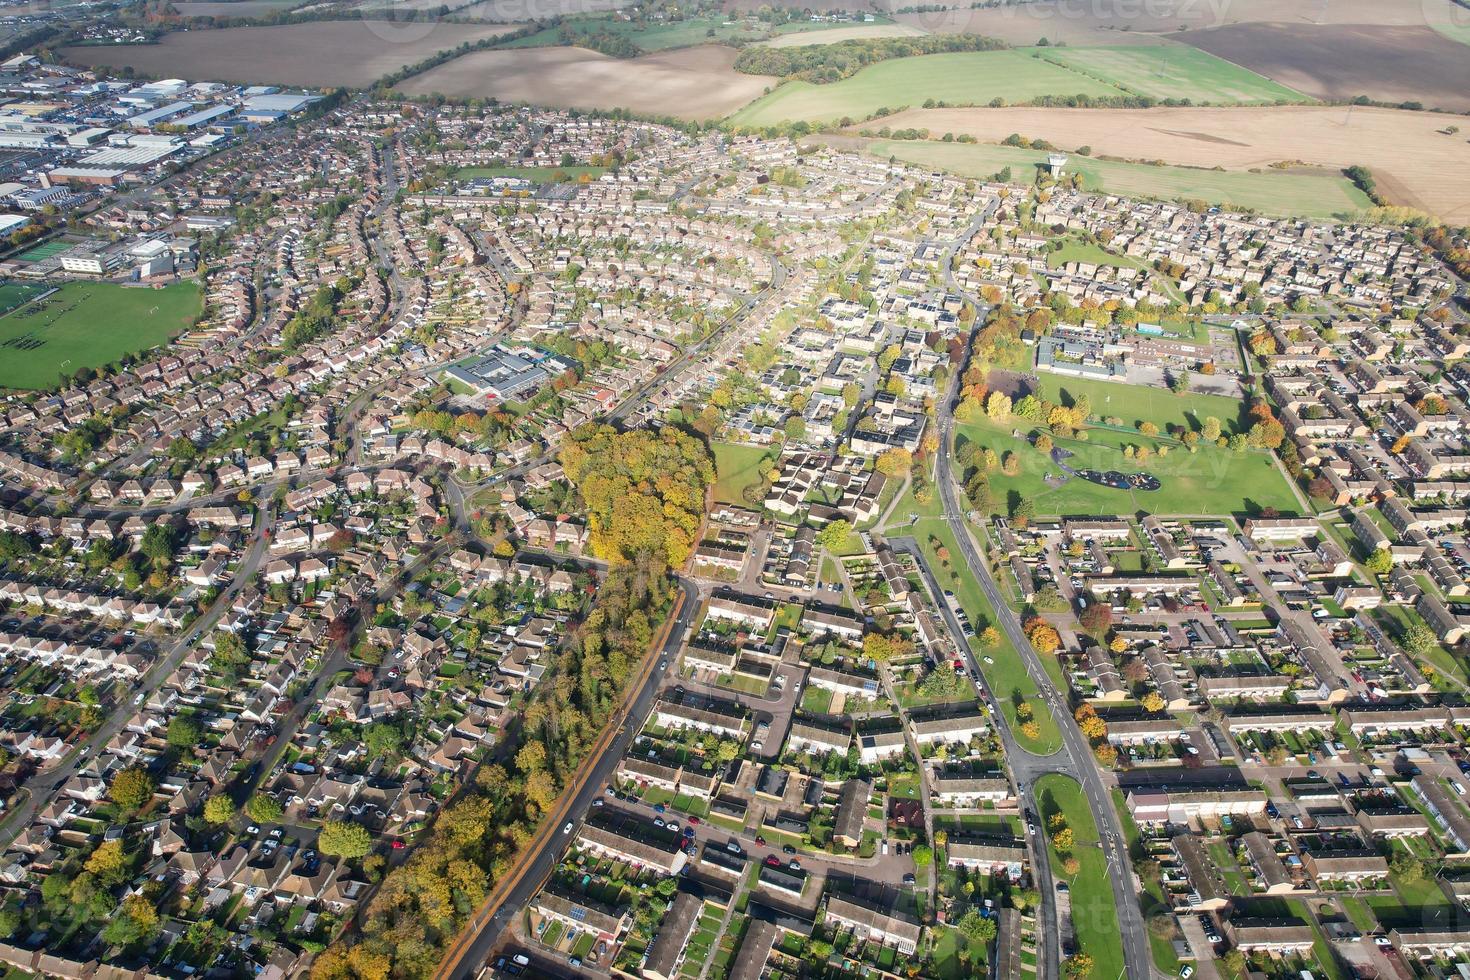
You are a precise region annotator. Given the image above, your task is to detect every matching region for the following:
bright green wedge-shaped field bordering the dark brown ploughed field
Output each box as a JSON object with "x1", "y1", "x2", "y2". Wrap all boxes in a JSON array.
[{"x1": 1042, "y1": 44, "x2": 1313, "y2": 106}]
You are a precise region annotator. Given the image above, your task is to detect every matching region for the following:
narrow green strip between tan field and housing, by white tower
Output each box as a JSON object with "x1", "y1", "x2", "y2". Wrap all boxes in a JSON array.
[{"x1": 858, "y1": 138, "x2": 1372, "y2": 217}]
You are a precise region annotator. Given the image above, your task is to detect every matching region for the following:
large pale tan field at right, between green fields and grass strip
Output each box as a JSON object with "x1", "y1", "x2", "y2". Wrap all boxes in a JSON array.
[{"x1": 858, "y1": 106, "x2": 1470, "y2": 220}]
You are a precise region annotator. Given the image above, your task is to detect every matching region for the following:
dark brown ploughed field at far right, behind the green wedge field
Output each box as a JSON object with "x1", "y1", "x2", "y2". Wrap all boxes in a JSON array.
[{"x1": 1177, "y1": 21, "x2": 1470, "y2": 112}]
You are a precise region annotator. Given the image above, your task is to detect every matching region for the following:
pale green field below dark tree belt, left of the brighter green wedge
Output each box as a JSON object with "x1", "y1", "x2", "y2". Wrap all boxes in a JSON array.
[{"x1": 728, "y1": 50, "x2": 1123, "y2": 126}]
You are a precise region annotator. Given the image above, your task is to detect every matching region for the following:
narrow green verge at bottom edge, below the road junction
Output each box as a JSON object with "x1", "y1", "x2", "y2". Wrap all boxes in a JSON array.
[{"x1": 1035, "y1": 773, "x2": 1123, "y2": 980}]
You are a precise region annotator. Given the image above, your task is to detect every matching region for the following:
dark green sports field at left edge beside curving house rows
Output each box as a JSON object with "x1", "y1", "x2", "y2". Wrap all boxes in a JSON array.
[{"x1": 0, "y1": 282, "x2": 203, "y2": 391}]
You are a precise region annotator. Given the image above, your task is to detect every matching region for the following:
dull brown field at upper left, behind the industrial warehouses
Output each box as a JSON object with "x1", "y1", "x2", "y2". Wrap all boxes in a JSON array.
[{"x1": 62, "y1": 21, "x2": 515, "y2": 88}]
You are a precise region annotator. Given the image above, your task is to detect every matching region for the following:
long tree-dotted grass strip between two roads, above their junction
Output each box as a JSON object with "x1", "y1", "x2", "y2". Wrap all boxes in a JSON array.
[{"x1": 900, "y1": 508, "x2": 1061, "y2": 755}]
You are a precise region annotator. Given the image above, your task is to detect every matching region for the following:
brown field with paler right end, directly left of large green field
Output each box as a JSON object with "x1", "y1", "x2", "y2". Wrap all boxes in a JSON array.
[{"x1": 398, "y1": 44, "x2": 776, "y2": 119}]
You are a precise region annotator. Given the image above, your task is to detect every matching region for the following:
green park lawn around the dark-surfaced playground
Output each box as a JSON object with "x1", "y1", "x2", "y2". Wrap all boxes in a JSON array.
[{"x1": 956, "y1": 419, "x2": 1299, "y2": 516}]
